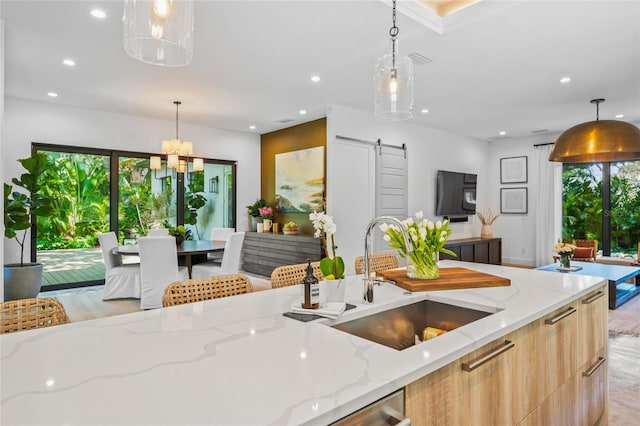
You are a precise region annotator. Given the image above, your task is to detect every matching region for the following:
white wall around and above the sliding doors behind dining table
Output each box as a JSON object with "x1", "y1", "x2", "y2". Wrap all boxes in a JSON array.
[{"x1": 2, "y1": 98, "x2": 260, "y2": 263}]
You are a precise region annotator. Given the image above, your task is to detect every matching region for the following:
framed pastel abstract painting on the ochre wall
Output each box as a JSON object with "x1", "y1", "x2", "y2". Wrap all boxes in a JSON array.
[{"x1": 276, "y1": 146, "x2": 324, "y2": 213}]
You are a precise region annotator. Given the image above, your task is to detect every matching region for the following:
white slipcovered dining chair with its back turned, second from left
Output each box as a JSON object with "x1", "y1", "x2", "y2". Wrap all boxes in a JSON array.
[{"x1": 138, "y1": 236, "x2": 189, "y2": 309}]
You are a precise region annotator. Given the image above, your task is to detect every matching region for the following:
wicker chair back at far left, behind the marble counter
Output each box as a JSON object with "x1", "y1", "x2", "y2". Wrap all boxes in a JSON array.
[{"x1": 0, "y1": 297, "x2": 69, "y2": 334}]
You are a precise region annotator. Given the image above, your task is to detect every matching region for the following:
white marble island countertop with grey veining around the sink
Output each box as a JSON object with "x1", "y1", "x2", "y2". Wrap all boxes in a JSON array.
[{"x1": 0, "y1": 261, "x2": 606, "y2": 425}]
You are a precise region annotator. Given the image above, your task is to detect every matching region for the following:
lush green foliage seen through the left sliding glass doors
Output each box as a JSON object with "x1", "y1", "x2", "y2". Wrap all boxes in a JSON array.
[{"x1": 37, "y1": 152, "x2": 207, "y2": 250}]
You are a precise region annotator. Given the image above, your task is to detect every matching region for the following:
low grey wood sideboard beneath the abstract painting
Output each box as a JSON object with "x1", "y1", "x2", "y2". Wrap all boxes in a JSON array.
[{"x1": 242, "y1": 232, "x2": 324, "y2": 277}]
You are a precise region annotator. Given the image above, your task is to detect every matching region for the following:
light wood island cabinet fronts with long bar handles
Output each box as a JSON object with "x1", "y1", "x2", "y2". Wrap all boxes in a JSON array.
[{"x1": 405, "y1": 286, "x2": 608, "y2": 426}]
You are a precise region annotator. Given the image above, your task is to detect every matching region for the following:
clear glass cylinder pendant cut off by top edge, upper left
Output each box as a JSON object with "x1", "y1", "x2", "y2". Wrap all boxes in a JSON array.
[{"x1": 123, "y1": 0, "x2": 193, "y2": 67}]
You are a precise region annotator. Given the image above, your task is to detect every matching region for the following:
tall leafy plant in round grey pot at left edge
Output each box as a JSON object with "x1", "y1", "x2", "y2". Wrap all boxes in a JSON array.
[{"x1": 4, "y1": 154, "x2": 51, "y2": 301}]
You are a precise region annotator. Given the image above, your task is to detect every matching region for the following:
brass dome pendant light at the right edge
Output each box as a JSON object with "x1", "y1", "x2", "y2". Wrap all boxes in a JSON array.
[{"x1": 549, "y1": 99, "x2": 640, "y2": 163}]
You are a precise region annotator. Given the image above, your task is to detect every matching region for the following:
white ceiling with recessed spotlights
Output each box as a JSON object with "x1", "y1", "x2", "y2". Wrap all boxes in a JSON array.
[{"x1": 0, "y1": 0, "x2": 640, "y2": 140}]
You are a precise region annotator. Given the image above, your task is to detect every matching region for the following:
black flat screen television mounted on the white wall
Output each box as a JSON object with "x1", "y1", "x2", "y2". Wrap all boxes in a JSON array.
[{"x1": 436, "y1": 170, "x2": 478, "y2": 216}]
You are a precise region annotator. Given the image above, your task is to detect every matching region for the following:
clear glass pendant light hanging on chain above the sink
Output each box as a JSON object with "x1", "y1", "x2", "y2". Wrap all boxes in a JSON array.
[{"x1": 373, "y1": 0, "x2": 413, "y2": 121}]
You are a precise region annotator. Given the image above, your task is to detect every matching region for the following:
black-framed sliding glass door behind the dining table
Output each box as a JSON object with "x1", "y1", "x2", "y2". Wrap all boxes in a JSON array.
[{"x1": 31, "y1": 144, "x2": 236, "y2": 290}]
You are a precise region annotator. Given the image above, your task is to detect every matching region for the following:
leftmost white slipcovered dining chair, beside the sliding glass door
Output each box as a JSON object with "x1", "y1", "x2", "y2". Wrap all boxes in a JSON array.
[{"x1": 98, "y1": 232, "x2": 142, "y2": 300}]
